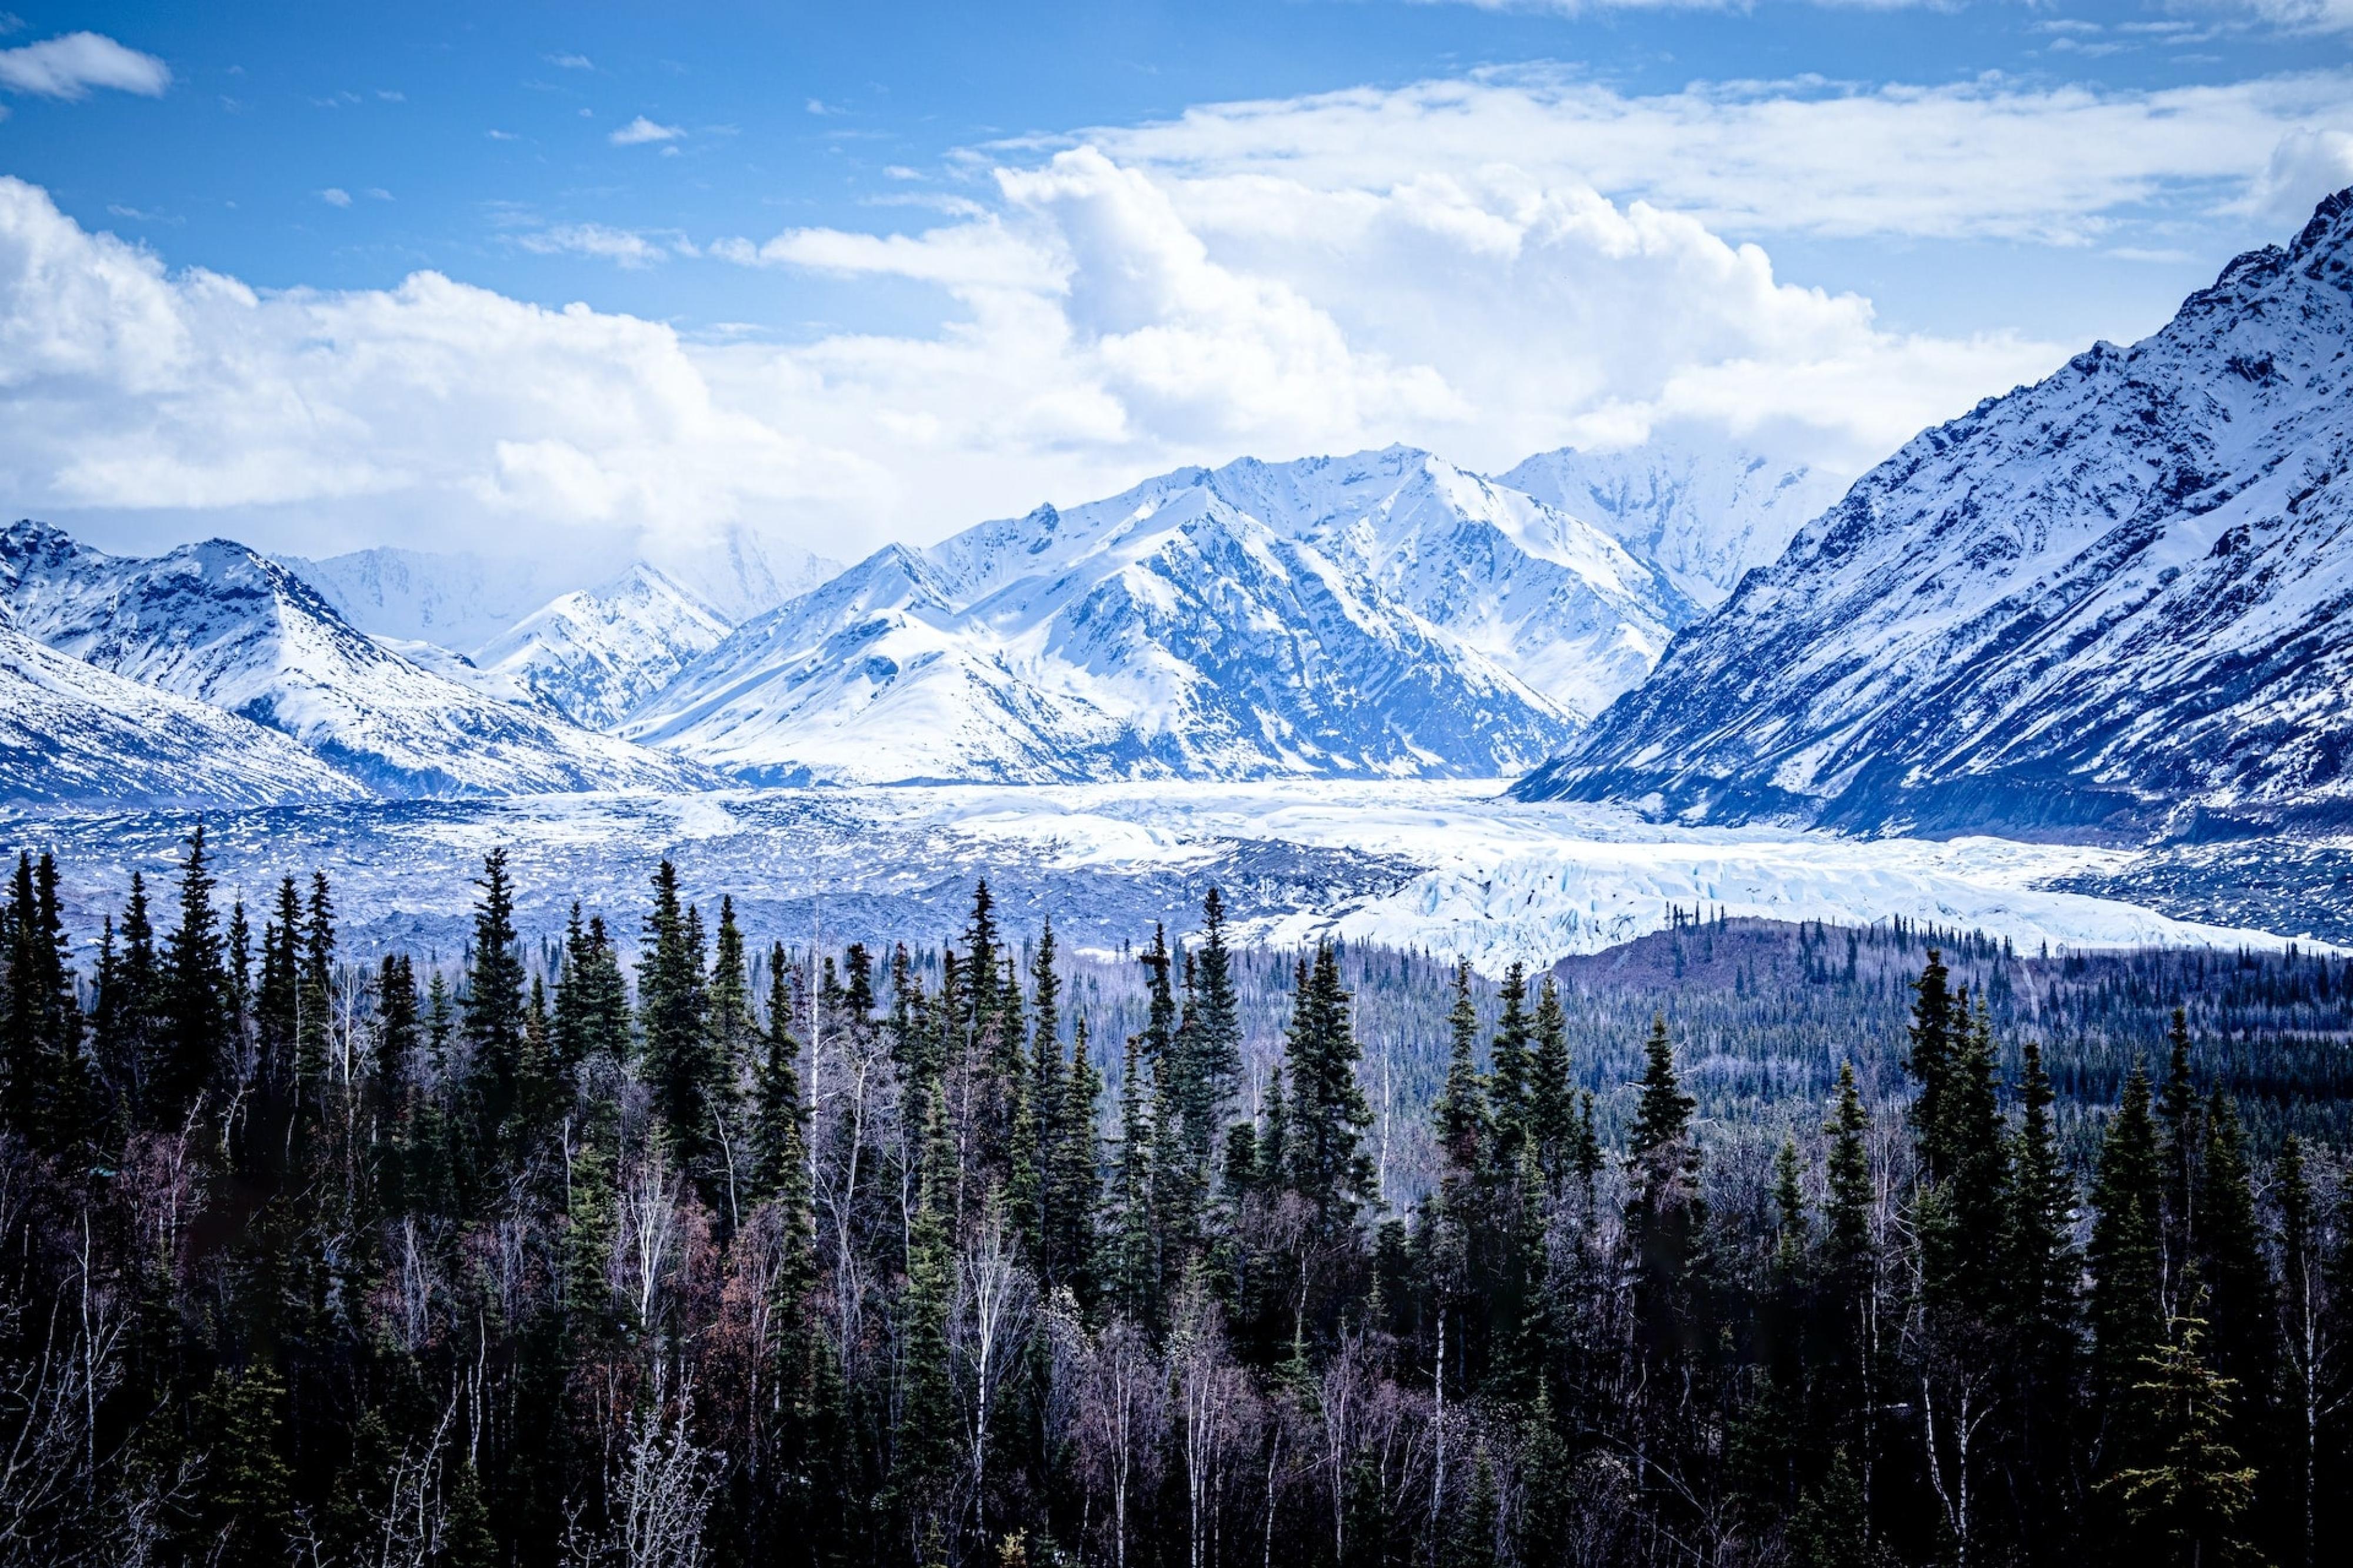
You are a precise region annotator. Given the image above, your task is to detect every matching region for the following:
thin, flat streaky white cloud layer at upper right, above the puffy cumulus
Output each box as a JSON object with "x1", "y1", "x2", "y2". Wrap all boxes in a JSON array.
[{"x1": 1085, "y1": 68, "x2": 2353, "y2": 245}]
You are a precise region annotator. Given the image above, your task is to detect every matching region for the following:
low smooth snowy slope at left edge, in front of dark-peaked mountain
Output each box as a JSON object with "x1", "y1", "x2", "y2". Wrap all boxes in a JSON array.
[{"x1": 0, "y1": 608, "x2": 367, "y2": 808}]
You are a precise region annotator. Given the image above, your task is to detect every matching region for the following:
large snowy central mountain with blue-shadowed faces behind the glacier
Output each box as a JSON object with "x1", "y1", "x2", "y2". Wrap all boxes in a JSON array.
[{"x1": 621, "y1": 448, "x2": 1692, "y2": 782}]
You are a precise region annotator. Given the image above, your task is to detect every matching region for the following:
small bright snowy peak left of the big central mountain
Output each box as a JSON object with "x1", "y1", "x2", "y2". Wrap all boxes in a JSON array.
[{"x1": 473, "y1": 565, "x2": 727, "y2": 728}]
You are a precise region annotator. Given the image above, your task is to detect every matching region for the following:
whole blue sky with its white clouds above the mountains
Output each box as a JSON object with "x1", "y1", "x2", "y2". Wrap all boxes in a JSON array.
[{"x1": 0, "y1": 0, "x2": 2353, "y2": 556}]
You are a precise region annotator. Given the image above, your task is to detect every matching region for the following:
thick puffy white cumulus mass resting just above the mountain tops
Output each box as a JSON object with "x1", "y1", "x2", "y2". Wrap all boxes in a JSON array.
[{"x1": 0, "y1": 148, "x2": 2061, "y2": 553}]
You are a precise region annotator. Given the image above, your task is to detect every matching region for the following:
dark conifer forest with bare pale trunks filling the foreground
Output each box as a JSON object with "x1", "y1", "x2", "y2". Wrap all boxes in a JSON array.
[{"x1": 0, "y1": 829, "x2": 2353, "y2": 1568}]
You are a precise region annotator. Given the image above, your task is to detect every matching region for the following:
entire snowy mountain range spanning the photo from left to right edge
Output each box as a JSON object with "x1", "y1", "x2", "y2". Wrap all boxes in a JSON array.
[{"x1": 0, "y1": 191, "x2": 2353, "y2": 840}]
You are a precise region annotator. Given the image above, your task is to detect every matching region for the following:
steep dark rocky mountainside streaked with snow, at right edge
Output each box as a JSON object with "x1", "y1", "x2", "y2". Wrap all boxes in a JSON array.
[{"x1": 1520, "y1": 191, "x2": 2353, "y2": 838}]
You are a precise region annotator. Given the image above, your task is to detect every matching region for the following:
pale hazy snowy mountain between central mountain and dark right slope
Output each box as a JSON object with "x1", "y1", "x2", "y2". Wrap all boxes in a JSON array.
[{"x1": 1504, "y1": 443, "x2": 1847, "y2": 608}]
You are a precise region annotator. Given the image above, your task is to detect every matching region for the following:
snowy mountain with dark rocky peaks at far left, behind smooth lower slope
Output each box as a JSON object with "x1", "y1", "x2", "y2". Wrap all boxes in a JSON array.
[{"x1": 0, "y1": 523, "x2": 711, "y2": 796}]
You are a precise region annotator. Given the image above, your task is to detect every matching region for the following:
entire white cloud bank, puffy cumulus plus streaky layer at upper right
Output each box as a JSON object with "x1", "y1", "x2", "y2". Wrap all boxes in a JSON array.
[{"x1": 0, "y1": 71, "x2": 2353, "y2": 567}]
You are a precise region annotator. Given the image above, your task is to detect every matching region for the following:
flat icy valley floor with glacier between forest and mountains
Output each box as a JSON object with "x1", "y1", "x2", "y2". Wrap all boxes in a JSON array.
[{"x1": 0, "y1": 779, "x2": 2334, "y2": 972}]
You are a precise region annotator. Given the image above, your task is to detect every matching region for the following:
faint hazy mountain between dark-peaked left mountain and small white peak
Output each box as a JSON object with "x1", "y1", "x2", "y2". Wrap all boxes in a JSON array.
[{"x1": 278, "y1": 546, "x2": 579, "y2": 655}]
